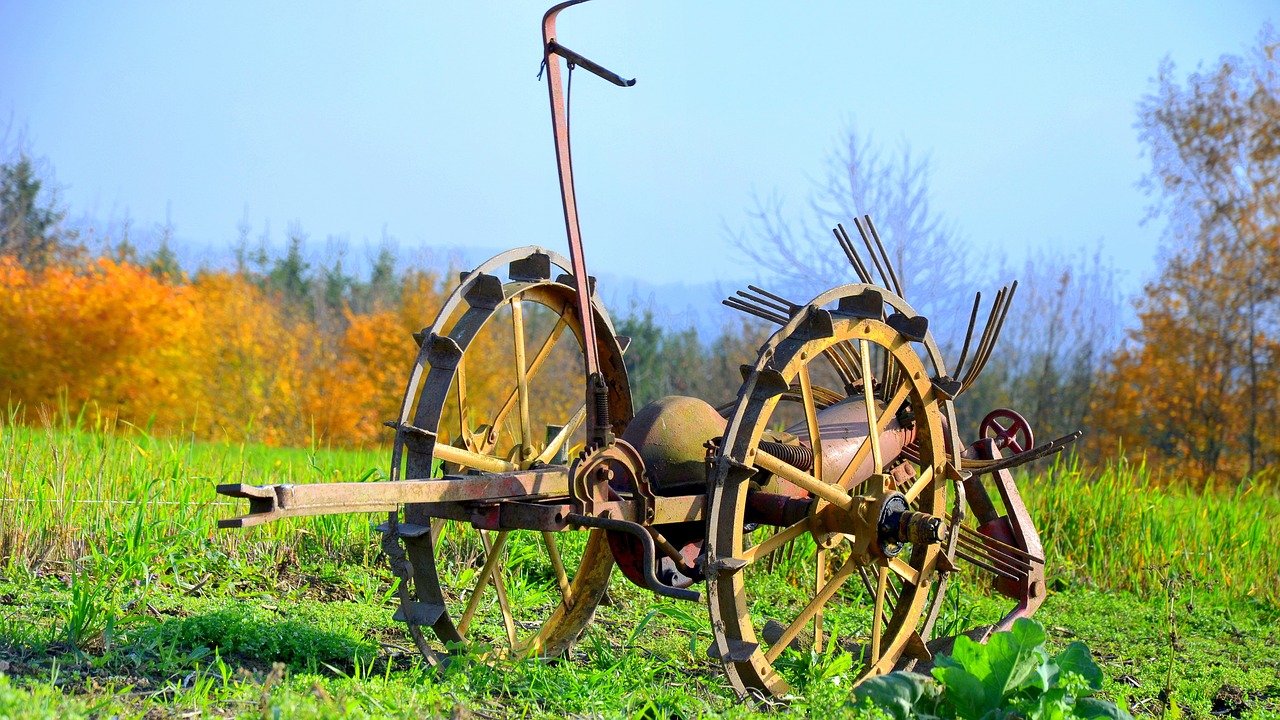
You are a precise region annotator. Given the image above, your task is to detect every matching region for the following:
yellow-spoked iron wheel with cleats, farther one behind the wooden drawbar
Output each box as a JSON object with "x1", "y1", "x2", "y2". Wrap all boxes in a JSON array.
[{"x1": 384, "y1": 247, "x2": 631, "y2": 662}]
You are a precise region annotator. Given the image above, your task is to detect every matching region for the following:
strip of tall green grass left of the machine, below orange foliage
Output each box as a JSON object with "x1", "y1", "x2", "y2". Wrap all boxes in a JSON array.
[{"x1": 0, "y1": 407, "x2": 387, "y2": 580}]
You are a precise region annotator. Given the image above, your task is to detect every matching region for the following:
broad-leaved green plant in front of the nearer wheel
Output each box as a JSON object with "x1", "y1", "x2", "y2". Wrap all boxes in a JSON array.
[{"x1": 855, "y1": 619, "x2": 1130, "y2": 720}]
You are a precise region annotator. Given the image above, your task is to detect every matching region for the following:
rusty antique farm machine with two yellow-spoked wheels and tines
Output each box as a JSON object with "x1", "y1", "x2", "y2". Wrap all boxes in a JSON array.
[{"x1": 218, "y1": 0, "x2": 1079, "y2": 697}]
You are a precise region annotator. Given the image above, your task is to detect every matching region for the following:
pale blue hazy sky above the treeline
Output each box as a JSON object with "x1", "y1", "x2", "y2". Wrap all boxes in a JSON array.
[{"x1": 0, "y1": 0, "x2": 1277, "y2": 316}]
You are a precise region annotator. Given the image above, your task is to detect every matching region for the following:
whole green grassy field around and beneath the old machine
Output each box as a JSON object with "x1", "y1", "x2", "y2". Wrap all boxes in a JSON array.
[{"x1": 0, "y1": 419, "x2": 1280, "y2": 717}]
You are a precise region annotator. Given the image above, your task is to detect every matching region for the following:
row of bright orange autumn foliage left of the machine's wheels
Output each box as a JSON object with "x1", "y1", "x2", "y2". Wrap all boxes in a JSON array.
[{"x1": 0, "y1": 258, "x2": 444, "y2": 446}]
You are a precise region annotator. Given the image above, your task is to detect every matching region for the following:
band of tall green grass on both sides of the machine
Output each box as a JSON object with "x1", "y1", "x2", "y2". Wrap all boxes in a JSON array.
[{"x1": 0, "y1": 418, "x2": 1280, "y2": 605}]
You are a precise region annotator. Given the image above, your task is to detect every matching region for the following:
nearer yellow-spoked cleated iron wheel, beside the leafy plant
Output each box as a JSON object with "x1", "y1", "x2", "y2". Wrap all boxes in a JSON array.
[{"x1": 708, "y1": 284, "x2": 963, "y2": 696}]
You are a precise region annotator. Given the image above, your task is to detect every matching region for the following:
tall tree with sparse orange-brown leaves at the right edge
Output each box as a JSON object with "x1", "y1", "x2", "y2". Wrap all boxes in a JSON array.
[{"x1": 1098, "y1": 26, "x2": 1280, "y2": 478}]
